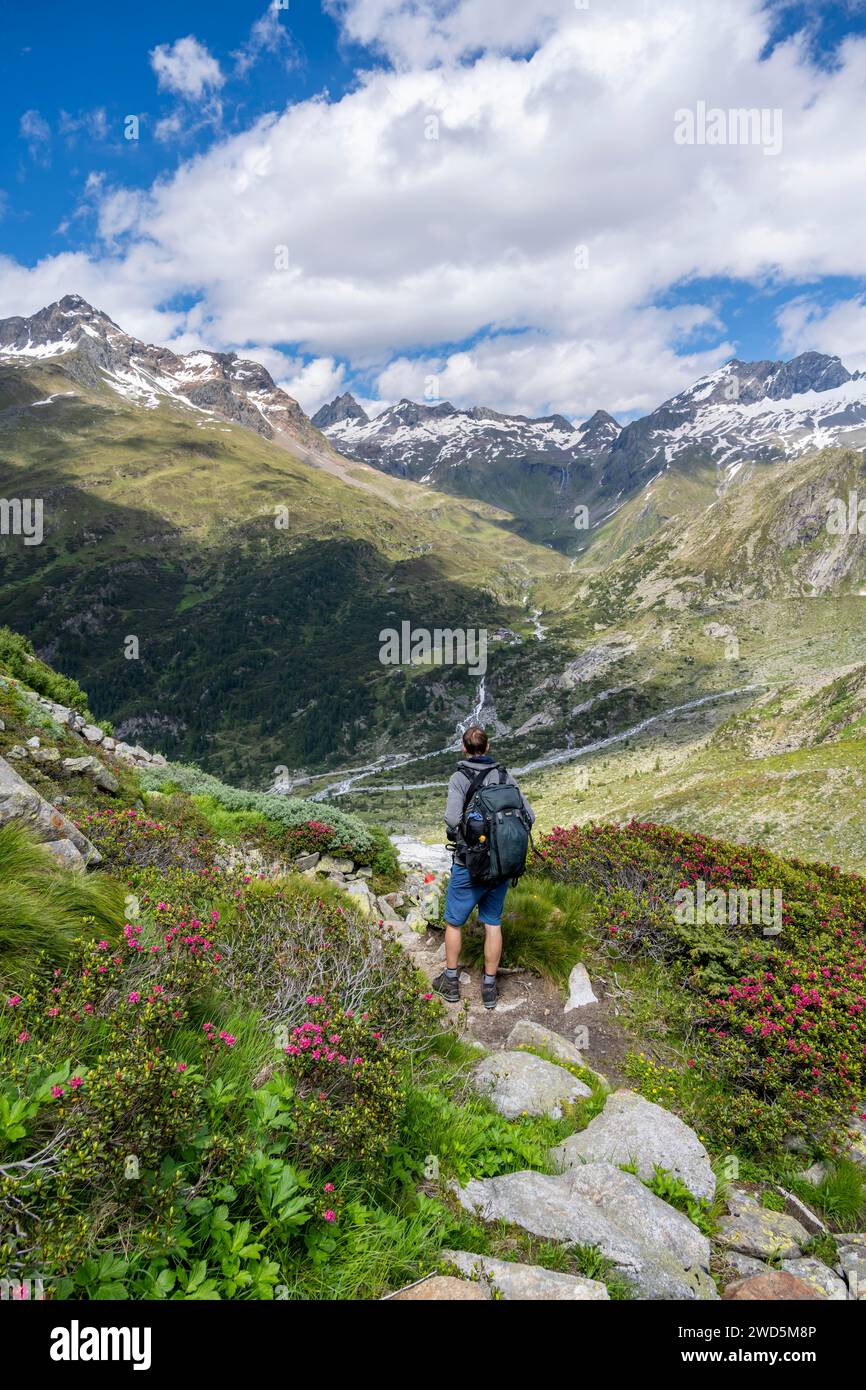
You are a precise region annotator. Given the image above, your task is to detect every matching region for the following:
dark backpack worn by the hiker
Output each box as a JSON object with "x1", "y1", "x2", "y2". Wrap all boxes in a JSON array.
[{"x1": 460, "y1": 763, "x2": 531, "y2": 884}]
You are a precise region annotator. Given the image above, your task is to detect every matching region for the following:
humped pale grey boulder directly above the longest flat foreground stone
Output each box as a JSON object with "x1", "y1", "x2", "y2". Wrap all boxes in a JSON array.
[{"x1": 550, "y1": 1090, "x2": 716, "y2": 1201}]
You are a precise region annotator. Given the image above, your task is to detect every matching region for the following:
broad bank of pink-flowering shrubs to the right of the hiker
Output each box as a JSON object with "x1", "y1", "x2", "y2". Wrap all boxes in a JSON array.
[{"x1": 541, "y1": 821, "x2": 866, "y2": 1151}]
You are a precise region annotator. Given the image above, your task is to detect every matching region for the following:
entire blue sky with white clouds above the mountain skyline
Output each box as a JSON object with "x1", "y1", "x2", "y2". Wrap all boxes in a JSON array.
[{"x1": 0, "y1": 0, "x2": 866, "y2": 418}]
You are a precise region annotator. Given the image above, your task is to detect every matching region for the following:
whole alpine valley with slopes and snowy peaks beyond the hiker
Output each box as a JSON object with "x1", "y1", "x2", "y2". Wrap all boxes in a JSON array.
[{"x1": 0, "y1": 295, "x2": 866, "y2": 866}]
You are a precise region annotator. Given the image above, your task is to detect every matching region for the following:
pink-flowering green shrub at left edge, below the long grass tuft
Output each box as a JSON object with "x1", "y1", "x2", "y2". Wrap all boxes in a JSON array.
[{"x1": 0, "y1": 922, "x2": 229, "y2": 1272}]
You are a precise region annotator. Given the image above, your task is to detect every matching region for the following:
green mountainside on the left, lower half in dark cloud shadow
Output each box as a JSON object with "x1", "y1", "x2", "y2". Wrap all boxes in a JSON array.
[{"x1": 0, "y1": 364, "x2": 562, "y2": 785}]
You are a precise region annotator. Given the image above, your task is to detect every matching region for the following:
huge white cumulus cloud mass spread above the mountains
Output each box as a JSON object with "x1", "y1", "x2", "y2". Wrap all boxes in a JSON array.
[{"x1": 0, "y1": 0, "x2": 866, "y2": 417}]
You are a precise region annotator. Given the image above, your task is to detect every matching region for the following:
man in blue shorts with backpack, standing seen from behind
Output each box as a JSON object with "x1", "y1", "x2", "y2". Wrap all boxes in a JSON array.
[{"x1": 434, "y1": 724, "x2": 535, "y2": 1009}]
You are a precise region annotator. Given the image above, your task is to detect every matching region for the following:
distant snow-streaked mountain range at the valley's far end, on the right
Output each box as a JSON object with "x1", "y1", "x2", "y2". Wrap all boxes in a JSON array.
[{"x1": 313, "y1": 353, "x2": 866, "y2": 553}]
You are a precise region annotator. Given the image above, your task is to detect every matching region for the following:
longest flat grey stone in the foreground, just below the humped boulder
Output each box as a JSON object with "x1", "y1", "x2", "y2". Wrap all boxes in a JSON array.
[{"x1": 456, "y1": 1163, "x2": 719, "y2": 1300}]
